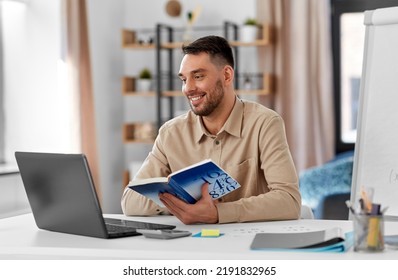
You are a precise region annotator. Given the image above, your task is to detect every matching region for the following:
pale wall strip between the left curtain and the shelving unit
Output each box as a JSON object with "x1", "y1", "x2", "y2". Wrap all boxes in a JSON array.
[{"x1": 87, "y1": 0, "x2": 124, "y2": 213}]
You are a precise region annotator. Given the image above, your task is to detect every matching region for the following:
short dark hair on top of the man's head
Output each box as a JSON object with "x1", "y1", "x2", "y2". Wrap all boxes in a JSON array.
[{"x1": 182, "y1": 35, "x2": 235, "y2": 68}]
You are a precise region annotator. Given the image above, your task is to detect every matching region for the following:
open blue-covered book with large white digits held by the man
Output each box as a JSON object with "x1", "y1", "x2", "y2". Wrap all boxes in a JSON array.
[{"x1": 128, "y1": 159, "x2": 240, "y2": 206}]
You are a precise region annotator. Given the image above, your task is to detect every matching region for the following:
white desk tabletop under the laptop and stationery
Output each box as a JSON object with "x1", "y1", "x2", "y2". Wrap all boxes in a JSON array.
[{"x1": 0, "y1": 214, "x2": 398, "y2": 260}]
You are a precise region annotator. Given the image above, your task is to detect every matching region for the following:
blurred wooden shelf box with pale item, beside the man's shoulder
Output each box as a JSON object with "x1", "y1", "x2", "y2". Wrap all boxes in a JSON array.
[{"x1": 123, "y1": 122, "x2": 156, "y2": 144}]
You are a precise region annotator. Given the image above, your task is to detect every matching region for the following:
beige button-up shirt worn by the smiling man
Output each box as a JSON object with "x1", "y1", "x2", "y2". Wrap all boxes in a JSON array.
[{"x1": 121, "y1": 98, "x2": 301, "y2": 223}]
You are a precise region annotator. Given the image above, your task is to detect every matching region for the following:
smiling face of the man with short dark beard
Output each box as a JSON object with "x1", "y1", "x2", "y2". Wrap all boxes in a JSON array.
[{"x1": 178, "y1": 53, "x2": 224, "y2": 116}]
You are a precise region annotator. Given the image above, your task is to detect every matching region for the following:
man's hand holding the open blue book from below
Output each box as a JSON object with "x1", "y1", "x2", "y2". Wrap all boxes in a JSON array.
[{"x1": 159, "y1": 183, "x2": 218, "y2": 225}]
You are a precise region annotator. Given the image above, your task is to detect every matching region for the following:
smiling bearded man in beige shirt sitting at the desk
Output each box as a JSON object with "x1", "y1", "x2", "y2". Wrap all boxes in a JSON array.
[{"x1": 122, "y1": 36, "x2": 301, "y2": 224}]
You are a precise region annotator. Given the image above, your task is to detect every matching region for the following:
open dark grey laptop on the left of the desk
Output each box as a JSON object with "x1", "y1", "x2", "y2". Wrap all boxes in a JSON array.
[{"x1": 15, "y1": 152, "x2": 175, "y2": 238}]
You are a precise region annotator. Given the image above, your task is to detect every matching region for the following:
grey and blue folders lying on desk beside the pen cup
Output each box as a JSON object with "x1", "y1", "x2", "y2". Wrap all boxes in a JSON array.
[{"x1": 250, "y1": 227, "x2": 353, "y2": 252}]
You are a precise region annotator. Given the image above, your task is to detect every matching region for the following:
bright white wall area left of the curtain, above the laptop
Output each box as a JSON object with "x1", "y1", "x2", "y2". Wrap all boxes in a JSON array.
[{"x1": 1, "y1": 0, "x2": 69, "y2": 162}]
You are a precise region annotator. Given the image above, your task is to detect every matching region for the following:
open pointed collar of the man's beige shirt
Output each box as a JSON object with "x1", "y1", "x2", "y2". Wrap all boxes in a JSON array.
[{"x1": 190, "y1": 97, "x2": 244, "y2": 142}]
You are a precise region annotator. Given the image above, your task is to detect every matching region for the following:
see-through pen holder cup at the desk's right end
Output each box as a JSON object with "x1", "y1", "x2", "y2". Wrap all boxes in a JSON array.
[{"x1": 354, "y1": 214, "x2": 384, "y2": 252}]
